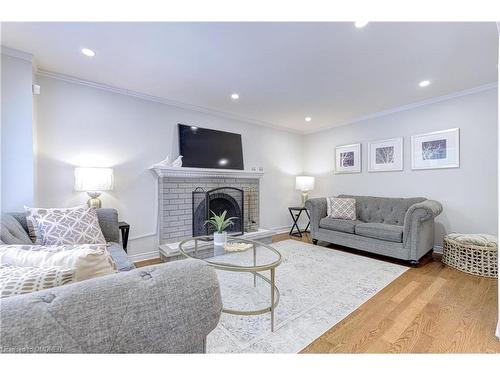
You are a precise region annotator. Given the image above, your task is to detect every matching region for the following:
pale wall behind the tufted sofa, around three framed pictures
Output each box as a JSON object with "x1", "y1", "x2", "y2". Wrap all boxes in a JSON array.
[{"x1": 304, "y1": 89, "x2": 497, "y2": 245}]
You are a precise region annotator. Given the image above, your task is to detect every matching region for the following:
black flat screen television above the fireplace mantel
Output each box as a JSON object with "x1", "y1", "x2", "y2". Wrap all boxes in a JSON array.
[{"x1": 178, "y1": 124, "x2": 243, "y2": 169}]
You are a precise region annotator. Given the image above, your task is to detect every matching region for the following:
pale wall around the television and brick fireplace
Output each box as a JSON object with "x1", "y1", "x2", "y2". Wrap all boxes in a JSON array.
[{"x1": 36, "y1": 76, "x2": 302, "y2": 254}]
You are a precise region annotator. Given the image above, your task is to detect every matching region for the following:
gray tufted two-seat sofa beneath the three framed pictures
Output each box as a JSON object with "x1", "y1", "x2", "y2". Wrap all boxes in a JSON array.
[{"x1": 306, "y1": 195, "x2": 443, "y2": 266}]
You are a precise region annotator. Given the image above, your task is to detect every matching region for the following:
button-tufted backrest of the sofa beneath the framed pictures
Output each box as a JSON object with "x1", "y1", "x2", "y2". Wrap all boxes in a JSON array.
[{"x1": 339, "y1": 195, "x2": 426, "y2": 225}]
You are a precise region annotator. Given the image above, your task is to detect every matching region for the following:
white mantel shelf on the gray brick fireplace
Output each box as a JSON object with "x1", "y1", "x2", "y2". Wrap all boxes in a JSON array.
[{"x1": 151, "y1": 167, "x2": 264, "y2": 178}]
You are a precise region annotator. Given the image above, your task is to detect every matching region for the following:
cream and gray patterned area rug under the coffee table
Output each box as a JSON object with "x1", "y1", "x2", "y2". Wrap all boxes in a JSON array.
[{"x1": 207, "y1": 240, "x2": 408, "y2": 353}]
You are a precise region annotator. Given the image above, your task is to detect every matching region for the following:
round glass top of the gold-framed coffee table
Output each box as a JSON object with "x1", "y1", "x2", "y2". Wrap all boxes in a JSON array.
[{"x1": 179, "y1": 236, "x2": 281, "y2": 272}]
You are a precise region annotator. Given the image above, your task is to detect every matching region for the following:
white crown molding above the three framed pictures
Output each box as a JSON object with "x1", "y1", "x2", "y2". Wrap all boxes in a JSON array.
[{"x1": 303, "y1": 82, "x2": 498, "y2": 134}]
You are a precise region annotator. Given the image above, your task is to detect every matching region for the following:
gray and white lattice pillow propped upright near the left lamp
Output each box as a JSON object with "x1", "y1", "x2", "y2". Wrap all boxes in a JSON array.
[{"x1": 26, "y1": 206, "x2": 106, "y2": 245}]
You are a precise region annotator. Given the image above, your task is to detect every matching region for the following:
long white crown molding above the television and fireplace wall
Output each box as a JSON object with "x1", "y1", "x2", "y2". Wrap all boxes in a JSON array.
[{"x1": 36, "y1": 69, "x2": 303, "y2": 134}]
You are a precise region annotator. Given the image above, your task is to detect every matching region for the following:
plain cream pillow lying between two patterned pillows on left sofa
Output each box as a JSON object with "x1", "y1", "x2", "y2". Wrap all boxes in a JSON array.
[{"x1": 0, "y1": 245, "x2": 116, "y2": 281}]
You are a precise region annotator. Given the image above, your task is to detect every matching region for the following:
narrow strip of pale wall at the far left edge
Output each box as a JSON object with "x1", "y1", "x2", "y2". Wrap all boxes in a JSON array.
[{"x1": 1, "y1": 51, "x2": 34, "y2": 211}]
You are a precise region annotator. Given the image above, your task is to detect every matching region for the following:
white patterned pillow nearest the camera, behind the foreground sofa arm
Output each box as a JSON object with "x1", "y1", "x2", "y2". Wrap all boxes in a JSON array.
[{"x1": 0, "y1": 264, "x2": 75, "y2": 298}]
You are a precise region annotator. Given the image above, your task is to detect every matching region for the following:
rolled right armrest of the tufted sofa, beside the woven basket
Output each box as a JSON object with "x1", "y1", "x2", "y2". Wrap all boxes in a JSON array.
[{"x1": 403, "y1": 199, "x2": 443, "y2": 260}]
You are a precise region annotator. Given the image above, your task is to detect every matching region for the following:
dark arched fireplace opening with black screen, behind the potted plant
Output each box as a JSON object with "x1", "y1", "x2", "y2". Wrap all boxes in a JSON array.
[{"x1": 192, "y1": 186, "x2": 245, "y2": 236}]
